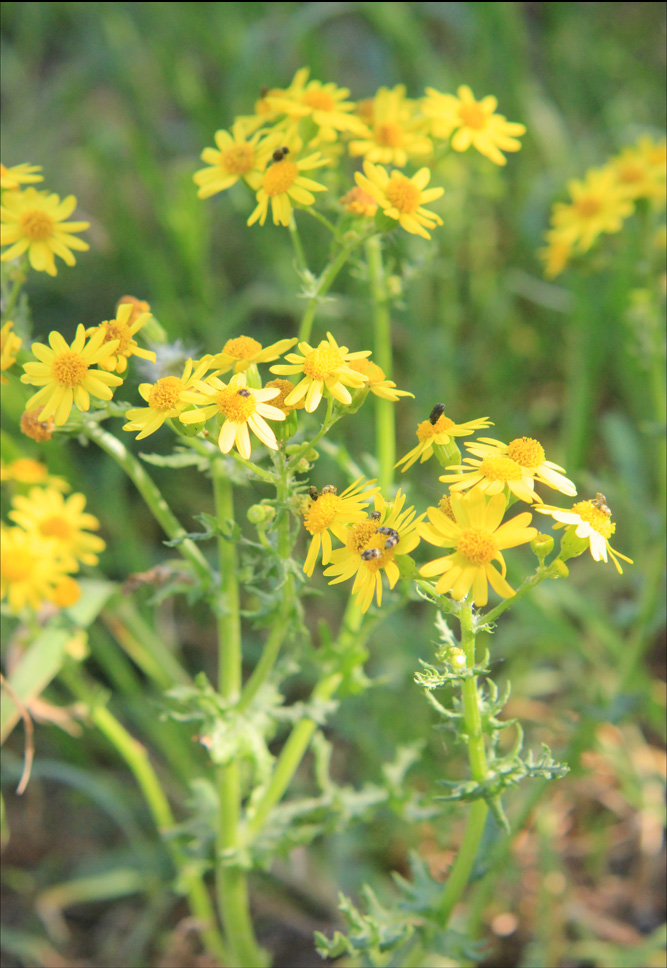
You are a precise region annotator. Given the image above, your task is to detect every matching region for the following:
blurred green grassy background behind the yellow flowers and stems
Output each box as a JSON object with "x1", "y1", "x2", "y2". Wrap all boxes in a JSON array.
[{"x1": 2, "y1": 2, "x2": 665, "y2": 966}]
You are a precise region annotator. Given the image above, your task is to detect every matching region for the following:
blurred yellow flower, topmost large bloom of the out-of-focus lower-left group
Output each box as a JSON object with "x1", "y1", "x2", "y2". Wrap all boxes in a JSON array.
[{"x1": 9, "y1": 487, "x2": 106, "y2": 572}]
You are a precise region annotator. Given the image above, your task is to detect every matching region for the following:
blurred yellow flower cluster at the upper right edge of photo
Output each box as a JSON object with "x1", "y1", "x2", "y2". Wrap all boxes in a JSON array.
[{"x1": 539, "y1": 136, "x2": 667, "y2": 279}]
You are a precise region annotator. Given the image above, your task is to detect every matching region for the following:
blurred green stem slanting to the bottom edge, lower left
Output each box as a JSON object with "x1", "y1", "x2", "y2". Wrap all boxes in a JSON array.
[{"x1": 61, "y1": 669, "x2": 230, "y2": 965}]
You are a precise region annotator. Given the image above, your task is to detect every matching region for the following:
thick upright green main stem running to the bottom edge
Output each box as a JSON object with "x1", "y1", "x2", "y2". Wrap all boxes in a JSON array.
[{"x1": 212, "y1": 460, "x2": 266, "y2": 968}]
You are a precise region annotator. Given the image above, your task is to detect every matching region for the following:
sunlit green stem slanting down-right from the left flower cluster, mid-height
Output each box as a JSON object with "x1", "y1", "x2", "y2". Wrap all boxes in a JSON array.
[{"x1": 82, "y1": 420, "x2": 211, "y2": 588}]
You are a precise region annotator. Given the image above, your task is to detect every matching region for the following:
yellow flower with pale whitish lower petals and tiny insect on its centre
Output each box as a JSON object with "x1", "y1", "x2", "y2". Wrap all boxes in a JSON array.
[{"x1": 180, "y1": 373, "x2": 285, "y2": 460}]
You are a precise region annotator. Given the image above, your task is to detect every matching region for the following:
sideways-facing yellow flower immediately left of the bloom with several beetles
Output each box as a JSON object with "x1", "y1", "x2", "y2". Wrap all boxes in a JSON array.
[{"x1": 303, "y1": 477, "x2": 378, "y2": 578}]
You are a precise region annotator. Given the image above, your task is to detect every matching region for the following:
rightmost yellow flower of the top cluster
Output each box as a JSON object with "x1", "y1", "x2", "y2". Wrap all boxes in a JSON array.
[{"x1": 422, "y1": 84, "x2": 526, "y2": 165}]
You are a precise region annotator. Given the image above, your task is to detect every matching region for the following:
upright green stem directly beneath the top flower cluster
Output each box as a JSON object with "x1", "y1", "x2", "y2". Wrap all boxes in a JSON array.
[{"x1": 365, "y1": 235, "x2": 396, "y2": 494}]
